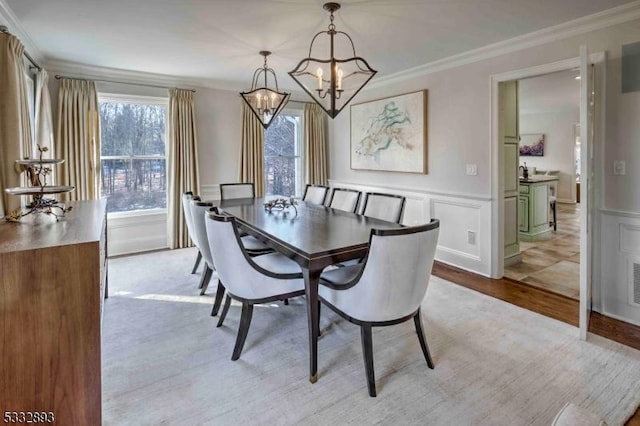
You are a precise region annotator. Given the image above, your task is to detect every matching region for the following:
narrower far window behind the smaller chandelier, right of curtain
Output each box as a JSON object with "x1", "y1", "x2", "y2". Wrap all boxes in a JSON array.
[{"x1": 264, "y1": 110, "x2": 303, "y2": 197}]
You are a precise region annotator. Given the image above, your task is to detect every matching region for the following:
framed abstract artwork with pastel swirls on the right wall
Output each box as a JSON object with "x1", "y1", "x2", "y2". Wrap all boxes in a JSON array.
[{"x1": 351, "y1": 90, "x2": 427, "y2": 173}]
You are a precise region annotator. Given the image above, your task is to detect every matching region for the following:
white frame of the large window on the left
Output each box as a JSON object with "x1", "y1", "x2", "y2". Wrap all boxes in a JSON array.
[{"x1": 98, "y1": 92, "x2": 169, "y2": 219}]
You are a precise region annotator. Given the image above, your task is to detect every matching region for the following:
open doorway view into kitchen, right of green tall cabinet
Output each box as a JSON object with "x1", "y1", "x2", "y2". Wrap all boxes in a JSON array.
[{"x1": 504, "y1": 68, "x2": 580, "y2": 300}]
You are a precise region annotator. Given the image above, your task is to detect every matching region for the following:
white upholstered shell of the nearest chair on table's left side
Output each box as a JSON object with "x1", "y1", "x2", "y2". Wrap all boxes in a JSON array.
[{"x1": 206, "y1": 209, "x2": 300, "y2": 300}]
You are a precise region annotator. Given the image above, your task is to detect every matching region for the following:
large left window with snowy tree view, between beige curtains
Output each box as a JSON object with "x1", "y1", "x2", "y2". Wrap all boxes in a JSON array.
[{"x1": 99, "y1": 96, "x2": 167, "y2": 212}]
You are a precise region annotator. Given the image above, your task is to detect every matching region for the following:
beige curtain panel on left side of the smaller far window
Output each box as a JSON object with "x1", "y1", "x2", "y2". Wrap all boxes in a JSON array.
[{"x1": 238, "y1": 102, "x2": 264, "y2": 197}]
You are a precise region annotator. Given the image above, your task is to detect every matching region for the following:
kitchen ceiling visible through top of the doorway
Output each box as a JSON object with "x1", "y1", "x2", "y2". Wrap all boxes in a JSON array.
[{"x1": 518, "y1": 69, "x2": 580, "y2": 115}]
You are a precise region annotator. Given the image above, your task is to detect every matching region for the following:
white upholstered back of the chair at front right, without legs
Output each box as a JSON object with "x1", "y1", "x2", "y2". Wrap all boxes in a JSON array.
[{"x1": 342, "y1": 219, "x2": 440, "y2": 322}]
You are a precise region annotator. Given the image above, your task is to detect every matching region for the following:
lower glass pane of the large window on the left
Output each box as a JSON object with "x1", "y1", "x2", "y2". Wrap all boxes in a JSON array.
[{"x1": 101, "y1": 159, "x2": 167, "y2": 212}]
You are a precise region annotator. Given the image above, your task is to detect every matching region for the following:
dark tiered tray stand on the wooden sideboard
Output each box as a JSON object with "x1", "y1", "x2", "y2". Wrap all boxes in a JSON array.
[{"x1": 5, "y1": 145, "x2": 75, "y2": 222}]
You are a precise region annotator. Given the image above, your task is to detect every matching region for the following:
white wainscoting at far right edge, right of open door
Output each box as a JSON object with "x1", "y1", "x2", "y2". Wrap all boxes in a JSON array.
[{"x1": 600, "y1": 211, "x2": 640, "y2": 325}]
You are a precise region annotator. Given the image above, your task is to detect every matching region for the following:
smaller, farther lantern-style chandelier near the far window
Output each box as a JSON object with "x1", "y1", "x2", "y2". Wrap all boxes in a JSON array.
[{"x1": 240, "y1": 50, "x2": 291, "y2": 129}]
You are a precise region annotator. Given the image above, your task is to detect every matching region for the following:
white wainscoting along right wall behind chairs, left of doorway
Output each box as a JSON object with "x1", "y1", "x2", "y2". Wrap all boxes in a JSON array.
[{"x1": 329, "y1": 180, "x2": 492, "y2": 277}]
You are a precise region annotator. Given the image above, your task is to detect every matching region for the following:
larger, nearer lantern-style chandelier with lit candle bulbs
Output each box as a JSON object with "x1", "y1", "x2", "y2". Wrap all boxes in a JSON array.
[{"x1": 289, "y1": 3, "x2": 377, "y2": 118}]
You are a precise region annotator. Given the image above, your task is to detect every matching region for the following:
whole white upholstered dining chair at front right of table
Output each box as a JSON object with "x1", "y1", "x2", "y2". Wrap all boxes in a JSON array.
[{"x1": 318, "y1": 219, "x2": 440, "y2": 396}]
